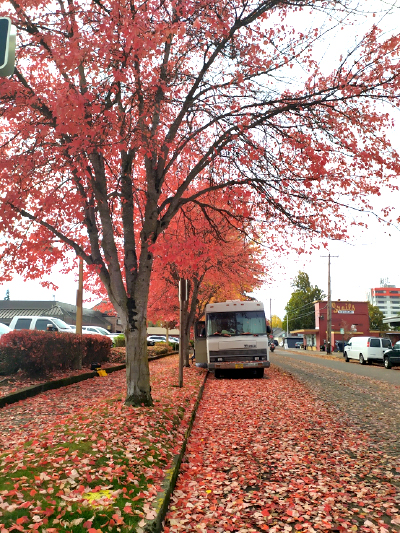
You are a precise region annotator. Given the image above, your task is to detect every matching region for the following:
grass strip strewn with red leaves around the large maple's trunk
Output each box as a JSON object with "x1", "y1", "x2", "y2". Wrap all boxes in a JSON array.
[{"x1": 0, "y1": 356, "x2": 204, "y2": 533}]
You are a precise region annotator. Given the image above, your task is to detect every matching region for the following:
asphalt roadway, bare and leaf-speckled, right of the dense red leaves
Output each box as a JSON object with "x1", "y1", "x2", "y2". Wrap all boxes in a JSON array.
[{"x1": 266, "y1": 350, "x2": 400, "y2": 457}]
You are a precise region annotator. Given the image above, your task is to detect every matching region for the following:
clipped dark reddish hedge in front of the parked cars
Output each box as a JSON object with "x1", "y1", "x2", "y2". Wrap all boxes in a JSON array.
[{"x1": 0, "y1": 330, "x2": 111, "y2": 375}]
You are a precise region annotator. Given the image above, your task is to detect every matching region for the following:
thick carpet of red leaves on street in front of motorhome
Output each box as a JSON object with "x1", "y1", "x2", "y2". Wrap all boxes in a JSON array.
[{"x1": 164, "y1": 367, "x2": 400, "y2": 533}]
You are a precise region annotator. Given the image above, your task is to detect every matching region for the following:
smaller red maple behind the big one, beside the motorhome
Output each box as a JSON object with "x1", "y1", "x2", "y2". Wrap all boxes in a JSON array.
[{"x1": 148, "y1": 202, "x2": 267, "y2": 360}]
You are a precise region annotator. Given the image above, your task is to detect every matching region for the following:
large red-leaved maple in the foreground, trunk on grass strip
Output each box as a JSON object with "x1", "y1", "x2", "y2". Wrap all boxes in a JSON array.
[{"x1": 0, "y1": 0, "x2": 400, "y2": 404}]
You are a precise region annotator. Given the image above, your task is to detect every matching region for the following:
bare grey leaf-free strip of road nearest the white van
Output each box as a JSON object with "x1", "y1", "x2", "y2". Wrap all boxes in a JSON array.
[{"x1": 270, "y1": 349, "x2": 400, "y2": 385}]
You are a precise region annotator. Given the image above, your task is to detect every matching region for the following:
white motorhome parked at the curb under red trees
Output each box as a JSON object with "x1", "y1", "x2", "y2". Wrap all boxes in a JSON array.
[{"x1": 195, "y1": 300, "x2": 271, "y2": 378}]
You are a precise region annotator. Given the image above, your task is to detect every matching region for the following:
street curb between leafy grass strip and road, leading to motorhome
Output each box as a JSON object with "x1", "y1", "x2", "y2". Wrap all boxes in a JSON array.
[{"x1": 143, "y1": 372, "x2": 209, "y2": 533}]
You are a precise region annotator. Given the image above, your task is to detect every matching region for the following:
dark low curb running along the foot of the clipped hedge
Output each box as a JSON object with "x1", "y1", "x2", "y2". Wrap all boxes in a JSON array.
[{"x1": 0, "y1": 352, "x2": 176, "y2": 409}]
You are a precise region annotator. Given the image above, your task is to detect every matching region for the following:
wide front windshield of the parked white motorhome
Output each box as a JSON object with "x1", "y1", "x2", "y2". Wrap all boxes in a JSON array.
[{"x1": 206, "y1": 311, "x2": 267, "y2": 337}]
